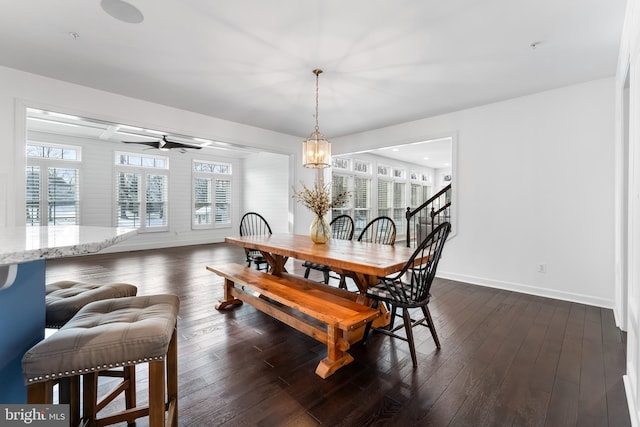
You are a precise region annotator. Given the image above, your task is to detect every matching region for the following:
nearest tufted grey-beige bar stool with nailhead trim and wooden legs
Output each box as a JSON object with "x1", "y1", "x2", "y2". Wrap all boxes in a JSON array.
[{"x1": 22, "y1": 295, "x2": 180, "y2": 427}]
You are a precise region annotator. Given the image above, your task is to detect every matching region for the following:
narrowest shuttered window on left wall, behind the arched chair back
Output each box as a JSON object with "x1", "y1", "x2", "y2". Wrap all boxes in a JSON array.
[{"x1": 192, "y1": 161, "x2": 231, "y2": 228}]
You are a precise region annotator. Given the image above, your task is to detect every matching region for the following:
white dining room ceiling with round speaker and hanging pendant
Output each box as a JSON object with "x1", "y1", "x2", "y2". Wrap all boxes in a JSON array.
[{"x1": 0, "y1": 0, "x2": 626, "y2": 147}]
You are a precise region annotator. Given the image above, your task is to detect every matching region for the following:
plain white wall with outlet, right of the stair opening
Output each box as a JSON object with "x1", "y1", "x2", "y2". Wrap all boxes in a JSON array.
[{"x1": 334, "y1": 79, "x2": 615, "y2": 307}]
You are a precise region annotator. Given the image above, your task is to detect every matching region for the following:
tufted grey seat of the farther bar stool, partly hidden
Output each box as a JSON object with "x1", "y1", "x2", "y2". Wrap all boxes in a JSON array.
[{"x1": 45, "y1": 280, "x2": 138, "y2": 329}]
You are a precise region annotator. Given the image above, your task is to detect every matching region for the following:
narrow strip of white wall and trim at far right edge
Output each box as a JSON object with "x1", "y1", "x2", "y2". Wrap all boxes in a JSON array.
[{"x1": 615, "y1": 0, "x2": 640, "y2": 426}]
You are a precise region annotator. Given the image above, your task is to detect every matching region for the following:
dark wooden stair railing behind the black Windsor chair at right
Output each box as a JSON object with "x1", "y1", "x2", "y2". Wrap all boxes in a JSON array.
[{"x1": 405, "y1": 184, "x2": 451, "y2": 247}]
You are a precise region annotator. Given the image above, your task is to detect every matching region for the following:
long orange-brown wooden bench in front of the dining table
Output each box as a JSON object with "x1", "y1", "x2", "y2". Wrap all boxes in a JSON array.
[{"x1": 207, "y1": 264, "x2": 381, "y2": 378}]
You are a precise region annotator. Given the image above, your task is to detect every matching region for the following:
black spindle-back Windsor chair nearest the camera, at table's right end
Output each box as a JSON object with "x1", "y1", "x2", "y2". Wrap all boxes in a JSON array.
[{"x1": 362, "y1": 222, "x2": 451, "y2": 367}]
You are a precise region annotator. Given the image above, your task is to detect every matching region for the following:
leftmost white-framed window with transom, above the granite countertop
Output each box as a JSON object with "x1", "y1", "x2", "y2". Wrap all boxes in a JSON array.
[{"x1": 25, "y1": 142, "x2": 81, "y2": 226}]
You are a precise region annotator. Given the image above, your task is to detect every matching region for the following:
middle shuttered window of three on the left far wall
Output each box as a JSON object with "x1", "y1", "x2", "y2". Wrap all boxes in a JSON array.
[{"x1": 115, "y1": 153, "x2": 169, "y2": 232}]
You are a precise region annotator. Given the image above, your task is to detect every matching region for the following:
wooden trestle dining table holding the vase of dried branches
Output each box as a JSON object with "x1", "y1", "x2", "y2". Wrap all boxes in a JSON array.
[{"x1": 225, "y1": 233, "x2": 414, "y2": 305}]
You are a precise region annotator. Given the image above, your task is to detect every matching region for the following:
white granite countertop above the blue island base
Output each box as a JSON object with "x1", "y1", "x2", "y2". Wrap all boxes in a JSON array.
[{"x1": 0, "y1": 225, "x2": 137, "y2": 265}]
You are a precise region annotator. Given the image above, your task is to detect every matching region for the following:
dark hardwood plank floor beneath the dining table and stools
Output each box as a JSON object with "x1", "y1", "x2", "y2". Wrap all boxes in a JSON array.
[{"x1": 47, "y1": 244, "x2": 631, "y2": 427}]
